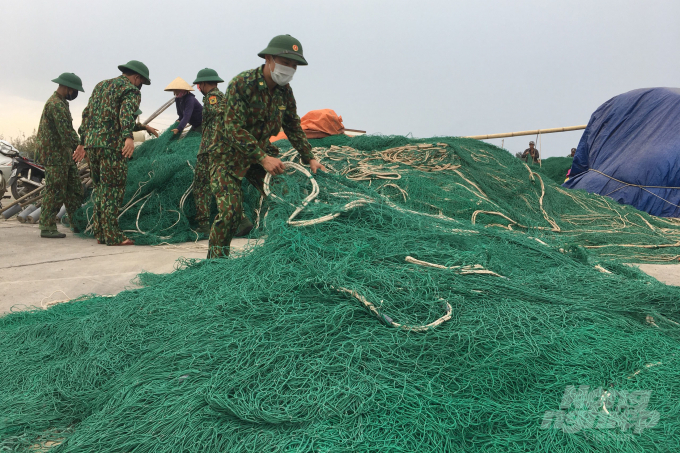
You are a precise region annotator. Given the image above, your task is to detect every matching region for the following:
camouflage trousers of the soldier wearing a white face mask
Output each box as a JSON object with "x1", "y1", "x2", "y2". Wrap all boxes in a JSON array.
[{"x1": 208, "y1": 160, "x2": 267, "y2": 258}]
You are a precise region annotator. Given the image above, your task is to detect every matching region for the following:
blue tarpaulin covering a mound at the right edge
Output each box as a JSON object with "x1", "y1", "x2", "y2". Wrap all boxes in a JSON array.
[{"x1": 563, "y1": 88, "x2": 680, "y2": 217}]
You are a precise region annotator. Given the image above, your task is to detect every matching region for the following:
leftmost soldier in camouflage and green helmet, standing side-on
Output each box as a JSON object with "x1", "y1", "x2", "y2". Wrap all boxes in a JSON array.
[{"x1": 36, "y1": 72, "x2": 84, "y2": 238}]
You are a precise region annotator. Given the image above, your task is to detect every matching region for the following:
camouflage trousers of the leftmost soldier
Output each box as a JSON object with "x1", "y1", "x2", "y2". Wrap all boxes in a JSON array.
[{"x1": 40, "y1": 162, "x2": 83, "y2": 230}]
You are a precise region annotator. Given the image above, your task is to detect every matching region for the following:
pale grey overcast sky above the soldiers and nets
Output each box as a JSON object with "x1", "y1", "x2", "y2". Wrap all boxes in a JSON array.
[{"x1": 0, "y1": 0, "x2": 680, "y2": 157}]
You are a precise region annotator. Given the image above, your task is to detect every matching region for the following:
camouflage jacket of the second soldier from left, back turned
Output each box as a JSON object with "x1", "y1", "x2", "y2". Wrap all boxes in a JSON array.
[{"x1": 78, "y1": 75, "x2": 142, "y2": 149}]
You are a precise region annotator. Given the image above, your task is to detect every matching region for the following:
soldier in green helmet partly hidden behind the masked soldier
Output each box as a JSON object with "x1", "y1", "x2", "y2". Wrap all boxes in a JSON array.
[{"x1": 194, "y1": 68, "x2": 225, "y2": 234}]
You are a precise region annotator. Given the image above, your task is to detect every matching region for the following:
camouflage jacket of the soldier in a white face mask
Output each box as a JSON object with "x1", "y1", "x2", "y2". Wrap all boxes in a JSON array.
[{"x1": 210, "y1": 65, "x2": 314, "y2": 178}]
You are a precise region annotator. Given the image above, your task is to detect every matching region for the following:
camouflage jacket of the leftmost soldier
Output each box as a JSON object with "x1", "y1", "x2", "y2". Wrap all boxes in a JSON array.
[{"x1": 36, "y1": 91, "x2": 79, "y2": 165}]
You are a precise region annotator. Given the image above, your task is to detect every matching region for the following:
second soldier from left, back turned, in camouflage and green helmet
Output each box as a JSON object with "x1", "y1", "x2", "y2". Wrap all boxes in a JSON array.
[{"x1": 73, "y1": 60, "x2": 151, "y2": 245}]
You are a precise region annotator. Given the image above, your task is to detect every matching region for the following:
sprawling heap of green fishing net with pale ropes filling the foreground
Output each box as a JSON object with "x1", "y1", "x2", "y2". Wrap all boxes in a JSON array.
[{"x1": 0, "y1": 131, "x2": 680, "y2": 452}]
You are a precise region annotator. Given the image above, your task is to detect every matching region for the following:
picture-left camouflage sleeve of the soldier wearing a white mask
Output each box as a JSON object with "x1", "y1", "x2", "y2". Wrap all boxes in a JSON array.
[{"x1": 224, "y1": 80, "x2": 267, "y2": 163}]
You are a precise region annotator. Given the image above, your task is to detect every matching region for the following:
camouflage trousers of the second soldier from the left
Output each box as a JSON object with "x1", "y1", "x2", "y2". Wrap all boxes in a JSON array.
[{"x1": 87, "y1": 148, "x2": 127, "y2": 245}]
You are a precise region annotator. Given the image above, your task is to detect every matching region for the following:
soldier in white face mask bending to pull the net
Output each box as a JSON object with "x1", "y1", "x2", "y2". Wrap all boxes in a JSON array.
[{"x1": 208, "y1": 35, "x2": 325, "y2": 258}]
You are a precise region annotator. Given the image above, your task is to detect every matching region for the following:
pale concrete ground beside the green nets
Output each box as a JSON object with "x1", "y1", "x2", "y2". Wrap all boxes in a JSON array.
[{"x1": 0, "y1": 217, "x2": 680, "y2": 316}]
